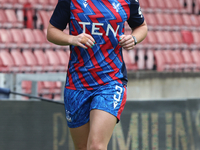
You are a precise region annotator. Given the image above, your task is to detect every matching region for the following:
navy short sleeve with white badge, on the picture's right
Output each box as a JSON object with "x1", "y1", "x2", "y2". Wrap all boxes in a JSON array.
[{"x1": 127, "y1": 0, "x2": 144, "y2": 28}]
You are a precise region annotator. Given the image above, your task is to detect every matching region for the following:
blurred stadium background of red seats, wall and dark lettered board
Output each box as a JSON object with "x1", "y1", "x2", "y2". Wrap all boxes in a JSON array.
[{"x1": 0, "y1": 0, "x2": 200, "y2": 150}]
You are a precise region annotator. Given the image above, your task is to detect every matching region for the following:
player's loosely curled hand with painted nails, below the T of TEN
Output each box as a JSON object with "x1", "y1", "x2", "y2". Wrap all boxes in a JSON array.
[{"x1": 71, "y1": 33, "x2": 95, "y2": 49}]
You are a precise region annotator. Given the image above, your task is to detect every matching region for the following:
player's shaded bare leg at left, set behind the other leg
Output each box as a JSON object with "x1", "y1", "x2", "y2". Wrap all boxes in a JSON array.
[{"x1": 69, "y1": 122, "x2": 89, "y2": 150}]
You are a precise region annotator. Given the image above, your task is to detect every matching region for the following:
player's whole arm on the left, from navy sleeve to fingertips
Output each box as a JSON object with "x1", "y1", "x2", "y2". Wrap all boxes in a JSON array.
[{"x1": 47, "y1": 0, "x2": 95, "y2": 49}]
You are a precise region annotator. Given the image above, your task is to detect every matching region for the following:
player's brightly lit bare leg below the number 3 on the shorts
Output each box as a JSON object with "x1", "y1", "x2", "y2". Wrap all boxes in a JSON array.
[{"x1": 87, "y1": 109, "x2": 117, "y2": 150}]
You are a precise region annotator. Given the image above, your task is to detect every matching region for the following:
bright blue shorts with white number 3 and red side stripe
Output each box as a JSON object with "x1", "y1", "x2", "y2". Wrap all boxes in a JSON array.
[{"x1": 64, "y1": 82, "x2": 127, "y2": 128}]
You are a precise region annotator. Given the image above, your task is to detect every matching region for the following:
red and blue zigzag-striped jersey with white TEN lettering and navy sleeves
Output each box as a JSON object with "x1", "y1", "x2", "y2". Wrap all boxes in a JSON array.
[{"x1": 50, "y1": 0, "x2": 144, "y2": 90}]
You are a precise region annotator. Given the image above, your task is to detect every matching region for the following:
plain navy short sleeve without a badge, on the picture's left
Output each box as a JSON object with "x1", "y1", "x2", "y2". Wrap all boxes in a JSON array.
[{"x1": 50, "y1": 0, "x2": 71, "y2": 30}]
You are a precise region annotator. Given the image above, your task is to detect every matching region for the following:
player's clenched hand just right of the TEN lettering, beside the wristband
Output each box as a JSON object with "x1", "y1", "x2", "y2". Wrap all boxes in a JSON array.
[{"x1": 119, "y1": 35, "x2": 135, "y2": 50}]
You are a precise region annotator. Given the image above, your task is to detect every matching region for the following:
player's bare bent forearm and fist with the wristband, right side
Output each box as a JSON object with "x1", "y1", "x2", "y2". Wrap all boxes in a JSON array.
[{"x1": 119, "y1": 20, "x2": 148, "y2": 50}]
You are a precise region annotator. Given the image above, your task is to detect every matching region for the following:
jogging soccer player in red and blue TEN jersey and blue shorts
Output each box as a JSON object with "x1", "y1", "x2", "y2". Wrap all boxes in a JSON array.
[{"x1": 47, "y1": 0, "x2": 147, "y2": 150}]
